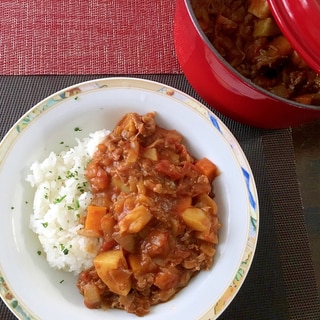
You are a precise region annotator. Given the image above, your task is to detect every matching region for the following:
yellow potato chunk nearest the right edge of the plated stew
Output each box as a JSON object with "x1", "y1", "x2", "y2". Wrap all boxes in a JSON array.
[{"x1": 182, "y1": 207, "x2": 211, "y2": 231}]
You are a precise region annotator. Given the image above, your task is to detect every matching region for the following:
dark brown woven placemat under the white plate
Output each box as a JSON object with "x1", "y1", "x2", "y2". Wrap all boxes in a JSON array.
[{"x1": 0, "y1": 74, "x2": 320, "y2": 320}]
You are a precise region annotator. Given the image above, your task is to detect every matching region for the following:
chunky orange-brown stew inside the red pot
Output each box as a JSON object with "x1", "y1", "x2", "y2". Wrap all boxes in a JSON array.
[{"x1": 191, "y1": 0, "x2": 320, "y2": 105}]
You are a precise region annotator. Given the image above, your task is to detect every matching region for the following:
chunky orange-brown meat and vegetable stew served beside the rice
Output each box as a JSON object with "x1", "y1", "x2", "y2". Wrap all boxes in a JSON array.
[{"x1": 77, "y1": 113, "x2": 221, "y2": 316}]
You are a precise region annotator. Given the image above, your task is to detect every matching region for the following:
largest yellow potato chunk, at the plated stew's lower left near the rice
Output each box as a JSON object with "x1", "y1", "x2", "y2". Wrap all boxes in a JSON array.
[{"x1": 93, "y1": 250, "x2": 132, "y2": 296}]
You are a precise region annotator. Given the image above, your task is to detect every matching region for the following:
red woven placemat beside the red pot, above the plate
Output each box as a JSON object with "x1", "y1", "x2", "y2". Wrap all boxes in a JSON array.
[{"x1": 0, "y1": 0, "x2": 181, "y2": 75}]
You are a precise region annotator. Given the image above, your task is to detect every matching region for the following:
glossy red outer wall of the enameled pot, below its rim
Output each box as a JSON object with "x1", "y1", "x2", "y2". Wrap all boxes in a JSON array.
[{"x1": 174, "y1": 0, "x2": 320, "y2": 129}]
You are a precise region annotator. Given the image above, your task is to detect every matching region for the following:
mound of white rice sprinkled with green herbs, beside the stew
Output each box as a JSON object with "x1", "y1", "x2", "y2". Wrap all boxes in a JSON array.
[{"x1": 26, "y1": 130, "x2": 108, "y2": 274}]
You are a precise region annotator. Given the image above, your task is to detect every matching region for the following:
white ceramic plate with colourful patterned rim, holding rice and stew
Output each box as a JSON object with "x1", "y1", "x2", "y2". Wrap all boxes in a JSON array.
[{"x1": 0, "y1": 78, "x2": 259, "y2": 320}]
